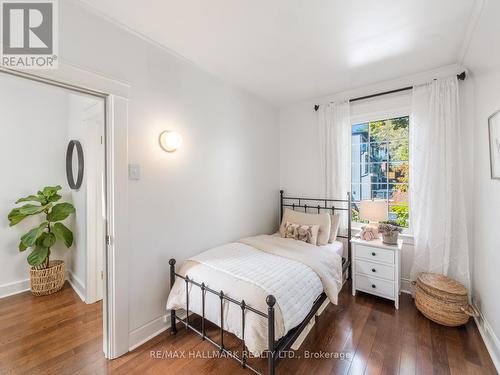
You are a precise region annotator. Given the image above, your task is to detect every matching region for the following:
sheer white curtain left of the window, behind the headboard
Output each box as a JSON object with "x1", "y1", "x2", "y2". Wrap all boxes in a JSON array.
[{"x1": 318, "y1": 101, "x2": 351, "y2": 227}]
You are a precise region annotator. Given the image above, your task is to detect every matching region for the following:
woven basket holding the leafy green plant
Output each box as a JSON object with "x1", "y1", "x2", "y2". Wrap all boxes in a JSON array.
[{"x1": 30, "y1": 260, "x2": 64, "y2": 296}]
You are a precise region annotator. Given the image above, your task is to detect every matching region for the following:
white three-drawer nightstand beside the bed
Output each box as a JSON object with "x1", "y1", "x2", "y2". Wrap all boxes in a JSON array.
[{"x1": 351, "y1": 238, "x2": 403, "y2": 309}]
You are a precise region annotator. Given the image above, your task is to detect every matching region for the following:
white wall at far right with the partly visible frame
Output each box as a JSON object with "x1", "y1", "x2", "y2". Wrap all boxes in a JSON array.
[{"x1": 466, "y1": 1, "x2": 500, "y2": 371}]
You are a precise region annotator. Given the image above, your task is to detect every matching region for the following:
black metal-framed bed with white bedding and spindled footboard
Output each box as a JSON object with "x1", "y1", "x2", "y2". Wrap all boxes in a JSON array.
[{"x1": 167, "y1": 191, "x2": 351, "y2": 374}]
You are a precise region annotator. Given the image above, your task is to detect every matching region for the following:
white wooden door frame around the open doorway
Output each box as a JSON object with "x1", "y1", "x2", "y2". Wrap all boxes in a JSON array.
[{"x1": 0, "y1": 61, "x2": 130, "y2": 359}]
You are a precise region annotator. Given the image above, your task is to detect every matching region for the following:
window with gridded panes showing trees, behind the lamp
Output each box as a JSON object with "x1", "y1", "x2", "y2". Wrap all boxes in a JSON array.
[{"x1": 351, "y1": 116, "x2": 410, "y2": 228}]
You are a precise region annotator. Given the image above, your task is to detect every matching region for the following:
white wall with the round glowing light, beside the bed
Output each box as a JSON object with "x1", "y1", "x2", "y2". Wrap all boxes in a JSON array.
[{"x1": 60, "y1": 1, "x2": 279, "y2": 346}]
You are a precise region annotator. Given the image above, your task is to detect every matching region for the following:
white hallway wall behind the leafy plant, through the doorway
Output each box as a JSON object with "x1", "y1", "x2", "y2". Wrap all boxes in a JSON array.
[{"x1": 0, "y1": 74, "x2": 69, "y2": 297}]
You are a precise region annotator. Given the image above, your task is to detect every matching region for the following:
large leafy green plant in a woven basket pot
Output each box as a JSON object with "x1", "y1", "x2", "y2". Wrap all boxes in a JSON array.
[{"x1": 8, "y1": 185, "x2": 75, "y2": 296}]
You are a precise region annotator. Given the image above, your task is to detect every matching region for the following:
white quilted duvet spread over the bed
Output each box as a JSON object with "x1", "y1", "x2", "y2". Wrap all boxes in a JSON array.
[{"x1": 167, "y1": 235, "x2": 342, "y2": 355}]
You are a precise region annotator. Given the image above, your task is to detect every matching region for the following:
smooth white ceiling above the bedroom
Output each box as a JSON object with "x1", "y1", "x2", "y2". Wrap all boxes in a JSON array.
[{"x1": 78, "y1": 0, "x2": 474, "y2": 106}]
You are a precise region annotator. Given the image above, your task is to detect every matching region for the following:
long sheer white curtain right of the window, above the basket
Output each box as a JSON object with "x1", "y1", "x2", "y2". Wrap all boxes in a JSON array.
[{"x1": 410, "y1": 77, "x2": 470, "y2": 288}]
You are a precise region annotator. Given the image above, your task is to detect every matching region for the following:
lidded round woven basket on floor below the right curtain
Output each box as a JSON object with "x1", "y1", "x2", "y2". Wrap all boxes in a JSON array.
[{"x1": 415, "y1": 273, "x2": 477, "y2": 327}]
